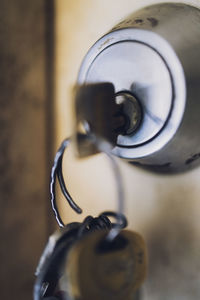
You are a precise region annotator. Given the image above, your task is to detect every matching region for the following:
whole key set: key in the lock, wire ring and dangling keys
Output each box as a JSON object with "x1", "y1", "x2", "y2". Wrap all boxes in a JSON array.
[{"x1": 34, "y1": 83, "x2": 147, "y2": 300}]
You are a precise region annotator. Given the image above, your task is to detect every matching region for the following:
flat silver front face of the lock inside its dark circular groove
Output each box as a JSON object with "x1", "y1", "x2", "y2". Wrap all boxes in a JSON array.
[{"x1": 85, "y1": 40, "x2": 173, "y2": 146}]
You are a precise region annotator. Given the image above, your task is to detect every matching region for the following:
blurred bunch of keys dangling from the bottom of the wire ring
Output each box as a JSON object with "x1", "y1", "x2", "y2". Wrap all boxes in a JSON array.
[{"x1": 34, "y1": 212, "x2": 147, "y2": 300}]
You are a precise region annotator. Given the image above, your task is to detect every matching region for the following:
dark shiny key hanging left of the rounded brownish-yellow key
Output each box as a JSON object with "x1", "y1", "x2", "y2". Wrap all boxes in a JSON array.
[{"x1": 34, "y1": 213, "x2": 119, "y2": 300}]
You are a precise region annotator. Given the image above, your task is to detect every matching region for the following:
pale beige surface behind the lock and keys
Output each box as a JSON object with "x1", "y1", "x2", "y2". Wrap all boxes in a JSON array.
[{"x1": 55, "y1": 0, "x2": 200, "y2": 300}]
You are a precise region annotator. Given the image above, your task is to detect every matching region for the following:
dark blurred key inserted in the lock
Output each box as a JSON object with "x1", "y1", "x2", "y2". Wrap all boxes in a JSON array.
[{"x1": 74, "y1": 82, "x2": 123, "y2": 157}]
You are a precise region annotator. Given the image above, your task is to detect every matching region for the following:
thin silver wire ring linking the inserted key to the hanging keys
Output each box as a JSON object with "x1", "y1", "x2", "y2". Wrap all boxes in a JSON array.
[{"x1": 50, "y1": 134, "x2": 124, "y2": 241}]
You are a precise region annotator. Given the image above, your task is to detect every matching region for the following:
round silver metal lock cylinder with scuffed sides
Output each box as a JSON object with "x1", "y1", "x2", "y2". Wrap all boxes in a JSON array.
[{"x1": 78, "y1": 3, "x2": 200, "y2": 173}]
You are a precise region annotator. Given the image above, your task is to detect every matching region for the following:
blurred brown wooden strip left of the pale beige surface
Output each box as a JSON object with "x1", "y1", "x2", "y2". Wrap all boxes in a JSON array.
[{"x1": 0, "y1": 0, "x2": 54, "y2": 300}]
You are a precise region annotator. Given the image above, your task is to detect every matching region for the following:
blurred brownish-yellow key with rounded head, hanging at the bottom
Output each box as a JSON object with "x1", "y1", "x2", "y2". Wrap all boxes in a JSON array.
[{"x1": 61, "y1": 230, "x2": 147, "y2": 300}]
